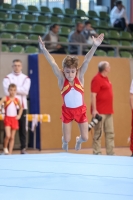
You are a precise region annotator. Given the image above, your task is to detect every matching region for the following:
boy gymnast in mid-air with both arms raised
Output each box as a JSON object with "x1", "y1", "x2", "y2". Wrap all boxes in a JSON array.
[{"x1": 39, "y1": 34, "x2": 104, "y2": 151}]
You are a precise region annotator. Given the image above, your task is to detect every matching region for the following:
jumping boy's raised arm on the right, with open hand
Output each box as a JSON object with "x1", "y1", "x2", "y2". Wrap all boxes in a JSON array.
[{"x1": 77, "y1": 34, "x2": 104, "y2": 84}]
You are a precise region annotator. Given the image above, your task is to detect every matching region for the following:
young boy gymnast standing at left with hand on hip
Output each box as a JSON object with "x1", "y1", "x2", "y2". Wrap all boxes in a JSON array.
[{"x1": 0, "y1": 84, "x2": 23, "y2": 155}]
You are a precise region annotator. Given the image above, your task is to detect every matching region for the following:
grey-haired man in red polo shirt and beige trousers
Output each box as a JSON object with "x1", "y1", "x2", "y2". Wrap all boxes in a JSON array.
[{"x1": 91, "y1": 61, "x2": 114, "y2": 155}]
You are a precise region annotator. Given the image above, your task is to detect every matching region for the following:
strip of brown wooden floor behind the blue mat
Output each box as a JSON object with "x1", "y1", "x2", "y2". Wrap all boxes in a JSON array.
[{"x1": 7, "y1": 148, "x2": 131, "y2": 156}]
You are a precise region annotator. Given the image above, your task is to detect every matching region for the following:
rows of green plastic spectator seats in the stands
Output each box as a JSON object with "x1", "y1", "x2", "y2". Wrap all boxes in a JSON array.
[{"x1": 0, "y1": 3, "x2": 133, "y2": 57}]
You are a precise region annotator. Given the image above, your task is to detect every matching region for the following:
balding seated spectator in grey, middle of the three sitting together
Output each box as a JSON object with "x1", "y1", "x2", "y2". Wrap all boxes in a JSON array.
[{"x1": 68, "y1": 22, "x2": 87, "y2": 55}]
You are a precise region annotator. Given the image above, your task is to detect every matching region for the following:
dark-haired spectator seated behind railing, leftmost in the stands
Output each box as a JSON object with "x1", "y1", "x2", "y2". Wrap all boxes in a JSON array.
[{"x1": 42, "y1": 24, "x2": 66, "y2": 54}]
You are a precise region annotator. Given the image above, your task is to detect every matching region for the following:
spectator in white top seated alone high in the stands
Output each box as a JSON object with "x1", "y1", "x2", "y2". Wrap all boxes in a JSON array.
[{"x1": 110, "y1": 1, "x2": 133, "y2": 31}]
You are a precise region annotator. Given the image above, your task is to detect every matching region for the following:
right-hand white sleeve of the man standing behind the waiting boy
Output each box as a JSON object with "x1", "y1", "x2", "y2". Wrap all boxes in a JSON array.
[{"x1": 17, "y1": 77, "x2": 31, "y2": 96}]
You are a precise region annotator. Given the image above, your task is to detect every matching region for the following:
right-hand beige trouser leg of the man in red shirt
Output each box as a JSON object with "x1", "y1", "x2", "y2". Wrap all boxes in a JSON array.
[{"x1": 104, "y1": 115, "x2": 114, "y2": 155}]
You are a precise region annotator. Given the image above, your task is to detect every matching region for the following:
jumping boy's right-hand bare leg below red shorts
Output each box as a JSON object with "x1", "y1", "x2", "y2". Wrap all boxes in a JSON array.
[{"x1": 75, "y1": 122, "x2": 88, "y2": 150}]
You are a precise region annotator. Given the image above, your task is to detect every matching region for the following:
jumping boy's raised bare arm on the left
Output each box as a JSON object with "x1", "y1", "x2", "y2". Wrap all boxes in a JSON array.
[{"x1": 39, "y1": 36, "x2": 64, "y2": 82}]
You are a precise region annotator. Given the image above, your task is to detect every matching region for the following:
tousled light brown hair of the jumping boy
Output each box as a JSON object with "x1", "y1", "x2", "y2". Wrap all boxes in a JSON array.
[{"x1": 62, "y1": 56, "x2": 78, "y2": 69}]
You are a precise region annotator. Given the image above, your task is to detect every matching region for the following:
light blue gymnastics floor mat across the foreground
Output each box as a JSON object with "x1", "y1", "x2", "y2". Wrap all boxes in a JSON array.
[{"x1": 0, "y1": 153, "x2": 133, "y2": 200}]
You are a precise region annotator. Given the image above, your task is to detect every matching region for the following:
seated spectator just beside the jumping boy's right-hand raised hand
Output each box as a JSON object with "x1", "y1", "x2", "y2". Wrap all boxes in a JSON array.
[{"x1": 82, "y1": 20, "x2": 98, "y2": 45}]
